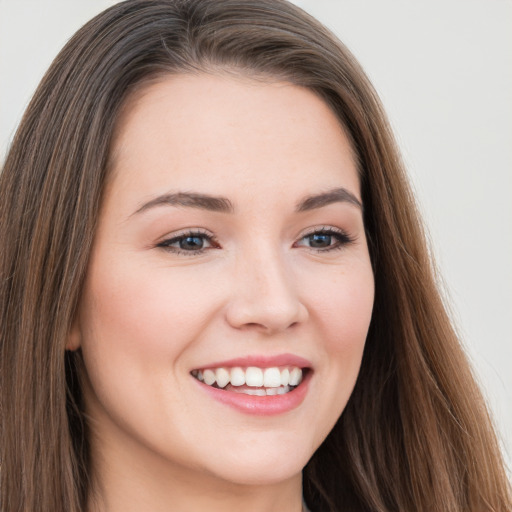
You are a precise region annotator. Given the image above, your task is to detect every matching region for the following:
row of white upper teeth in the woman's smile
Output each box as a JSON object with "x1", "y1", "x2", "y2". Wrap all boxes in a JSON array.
[{"x1": 192, "y1": 366, "x2": 302, "y2": 388}]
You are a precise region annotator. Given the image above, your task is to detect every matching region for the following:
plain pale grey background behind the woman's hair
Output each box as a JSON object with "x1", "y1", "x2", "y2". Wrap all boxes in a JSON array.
[{"x1": 0, "y1": 0, "x2": 512, "y2": 467}]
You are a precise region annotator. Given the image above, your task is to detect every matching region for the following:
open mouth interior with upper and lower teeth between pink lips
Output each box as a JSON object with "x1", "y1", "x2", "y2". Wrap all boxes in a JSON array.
[{"x1": 191, "y1": 366, "x2": 308, "y2": 396}]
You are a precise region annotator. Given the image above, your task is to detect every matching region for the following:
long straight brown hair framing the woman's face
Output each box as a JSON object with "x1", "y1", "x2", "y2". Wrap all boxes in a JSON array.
[{"x1": 0, "y1": 0, "x2": 511, "y2": 512}]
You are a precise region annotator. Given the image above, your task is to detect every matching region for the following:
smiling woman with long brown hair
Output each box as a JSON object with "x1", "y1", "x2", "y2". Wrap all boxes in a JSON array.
[{"x1": 0, "y1": 0, "x2": 510, "y2": 511}]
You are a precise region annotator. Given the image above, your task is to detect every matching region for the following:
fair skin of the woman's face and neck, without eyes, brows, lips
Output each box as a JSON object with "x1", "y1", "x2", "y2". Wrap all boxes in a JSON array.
[{"x1": 68, "y1": 74, "x2": 374, "y2": 512}]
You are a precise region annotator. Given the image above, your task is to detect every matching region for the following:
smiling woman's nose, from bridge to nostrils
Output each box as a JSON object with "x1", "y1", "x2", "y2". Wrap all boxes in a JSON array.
[{"x1": 226, "y1": 246, "x2": 308, "y2": 334}]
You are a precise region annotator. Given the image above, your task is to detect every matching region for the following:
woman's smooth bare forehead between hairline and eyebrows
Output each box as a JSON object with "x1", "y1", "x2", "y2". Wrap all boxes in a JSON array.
[{"x1": 107, "y1": 74, "x2": 359, "y2": 210}]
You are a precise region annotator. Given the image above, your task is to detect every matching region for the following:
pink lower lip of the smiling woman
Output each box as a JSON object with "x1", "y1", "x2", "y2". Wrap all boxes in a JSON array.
[{"x1": 196, "y1": 370, "x2": 313, "y2": 416}]
